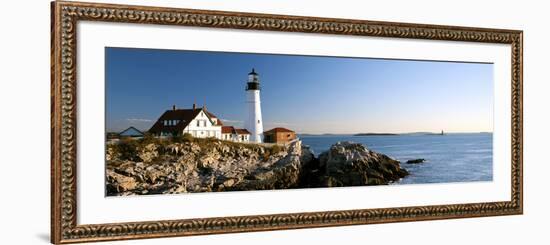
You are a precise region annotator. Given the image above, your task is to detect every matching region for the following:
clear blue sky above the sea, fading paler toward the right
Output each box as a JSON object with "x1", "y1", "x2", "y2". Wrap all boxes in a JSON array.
[{"x1": 105, "y1": 48, "x2": 493, "y2": 133}]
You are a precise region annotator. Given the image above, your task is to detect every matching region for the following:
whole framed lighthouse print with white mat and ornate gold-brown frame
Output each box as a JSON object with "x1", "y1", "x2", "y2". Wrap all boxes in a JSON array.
[{"x1": 51, "y1": 1, "x2": 523, "y2": 243}]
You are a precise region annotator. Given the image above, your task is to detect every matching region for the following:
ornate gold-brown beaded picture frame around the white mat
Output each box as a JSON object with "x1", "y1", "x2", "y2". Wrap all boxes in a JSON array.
[{"x1": 51, "y1": 1, "x2": 523, "y2": 244}]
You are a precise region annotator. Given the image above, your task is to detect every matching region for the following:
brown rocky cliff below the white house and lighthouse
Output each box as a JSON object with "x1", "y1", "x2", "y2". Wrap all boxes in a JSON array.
[{"x1": 106, "y1": 139, "x2": 407, "y2": 195}]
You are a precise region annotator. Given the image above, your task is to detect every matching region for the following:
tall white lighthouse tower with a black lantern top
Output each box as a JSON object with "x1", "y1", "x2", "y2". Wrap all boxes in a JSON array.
[{"x1": 244, "y1": 68, "x2": 264, "y2": 143}]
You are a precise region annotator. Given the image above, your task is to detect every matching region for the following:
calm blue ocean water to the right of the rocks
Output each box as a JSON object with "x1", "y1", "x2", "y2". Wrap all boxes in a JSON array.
[{"x1": 300, "y1": 133, "x2": 493, "y2": 184}]
